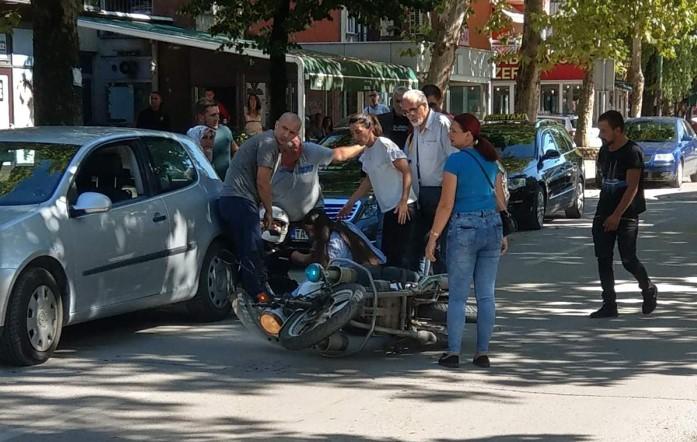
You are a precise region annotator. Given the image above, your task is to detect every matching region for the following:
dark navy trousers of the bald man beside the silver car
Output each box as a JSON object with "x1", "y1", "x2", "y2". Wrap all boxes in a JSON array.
[{"x1": 218, "y1": 197, "x2": 266, "y2": 298}]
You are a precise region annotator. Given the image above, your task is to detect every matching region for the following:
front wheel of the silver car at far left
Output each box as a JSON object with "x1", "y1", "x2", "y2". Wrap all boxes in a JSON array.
[{"x1": 0, "y1": 267, "x2": 63, "y2": 366}]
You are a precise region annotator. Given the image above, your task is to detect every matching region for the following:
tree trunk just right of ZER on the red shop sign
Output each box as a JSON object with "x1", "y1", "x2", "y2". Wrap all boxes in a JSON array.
[{"x1": 515, "y1": 0, "x2": 543, "y2": 121}]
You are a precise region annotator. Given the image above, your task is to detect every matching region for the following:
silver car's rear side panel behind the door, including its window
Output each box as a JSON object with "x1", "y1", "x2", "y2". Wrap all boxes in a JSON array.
[{"x1": 141, "y1": 137, "x2": 207, "y2": 300}]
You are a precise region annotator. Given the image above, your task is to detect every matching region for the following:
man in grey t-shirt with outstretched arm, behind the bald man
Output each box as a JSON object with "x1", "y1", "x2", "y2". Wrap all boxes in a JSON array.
[{"x1": 273, "y1": 143, "x2": 364, "y2": 222}]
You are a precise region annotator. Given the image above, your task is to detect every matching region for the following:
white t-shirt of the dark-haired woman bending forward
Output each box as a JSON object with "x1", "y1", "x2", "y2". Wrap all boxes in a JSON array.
[{"x1": 359, "y1": 137, "x2": 416, "y2": 213}]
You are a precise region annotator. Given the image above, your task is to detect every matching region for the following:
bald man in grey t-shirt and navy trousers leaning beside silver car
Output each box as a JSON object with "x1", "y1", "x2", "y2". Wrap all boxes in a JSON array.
[{"x1": 219, "y1": 112, "x2": 302, "y2": 301}]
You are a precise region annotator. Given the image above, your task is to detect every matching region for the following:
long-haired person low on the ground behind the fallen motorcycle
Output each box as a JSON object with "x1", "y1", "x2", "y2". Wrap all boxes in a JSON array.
[{"x1": 290, "y1": 209, "x2": 385, "y2": 267}]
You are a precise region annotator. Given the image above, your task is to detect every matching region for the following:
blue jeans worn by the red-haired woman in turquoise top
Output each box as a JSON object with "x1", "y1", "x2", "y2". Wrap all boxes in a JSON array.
[{"x1": 447, "y1": 210, "x2": 503, "y2": 354}]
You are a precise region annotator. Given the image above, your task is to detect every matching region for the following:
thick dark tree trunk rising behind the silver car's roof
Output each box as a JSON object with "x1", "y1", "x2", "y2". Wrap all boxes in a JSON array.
[{"x1": 31, "y1": 0, "x2": 82, "y2": 126}]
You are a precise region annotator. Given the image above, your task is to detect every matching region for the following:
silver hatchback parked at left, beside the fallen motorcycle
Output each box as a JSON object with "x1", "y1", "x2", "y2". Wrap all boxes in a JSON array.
[{"x1": 0, "y1": 127, "x2": 235, "y2": 365}]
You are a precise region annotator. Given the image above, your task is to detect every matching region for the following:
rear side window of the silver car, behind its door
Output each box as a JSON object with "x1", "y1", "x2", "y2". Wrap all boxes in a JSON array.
[{"x1": 143, "y1": 137, "x2": 197, "y2": 193}]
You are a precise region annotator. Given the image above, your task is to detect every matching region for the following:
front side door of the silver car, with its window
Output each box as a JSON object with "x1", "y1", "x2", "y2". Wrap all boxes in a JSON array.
[{"x1": 69, "y1": 140, "x2": 170, "y2": 312}]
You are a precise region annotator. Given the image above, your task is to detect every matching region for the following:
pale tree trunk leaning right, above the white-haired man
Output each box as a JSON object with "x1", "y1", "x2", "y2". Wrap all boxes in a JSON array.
[{"x1": 426, "y1": 0, "x2": 469, "y2": 91}]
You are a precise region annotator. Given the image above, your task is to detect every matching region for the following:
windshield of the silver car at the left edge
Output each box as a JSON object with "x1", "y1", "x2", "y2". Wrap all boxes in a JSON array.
[{"x1": 0, "y1": 142, "x2": 79, "y2": 206}]
